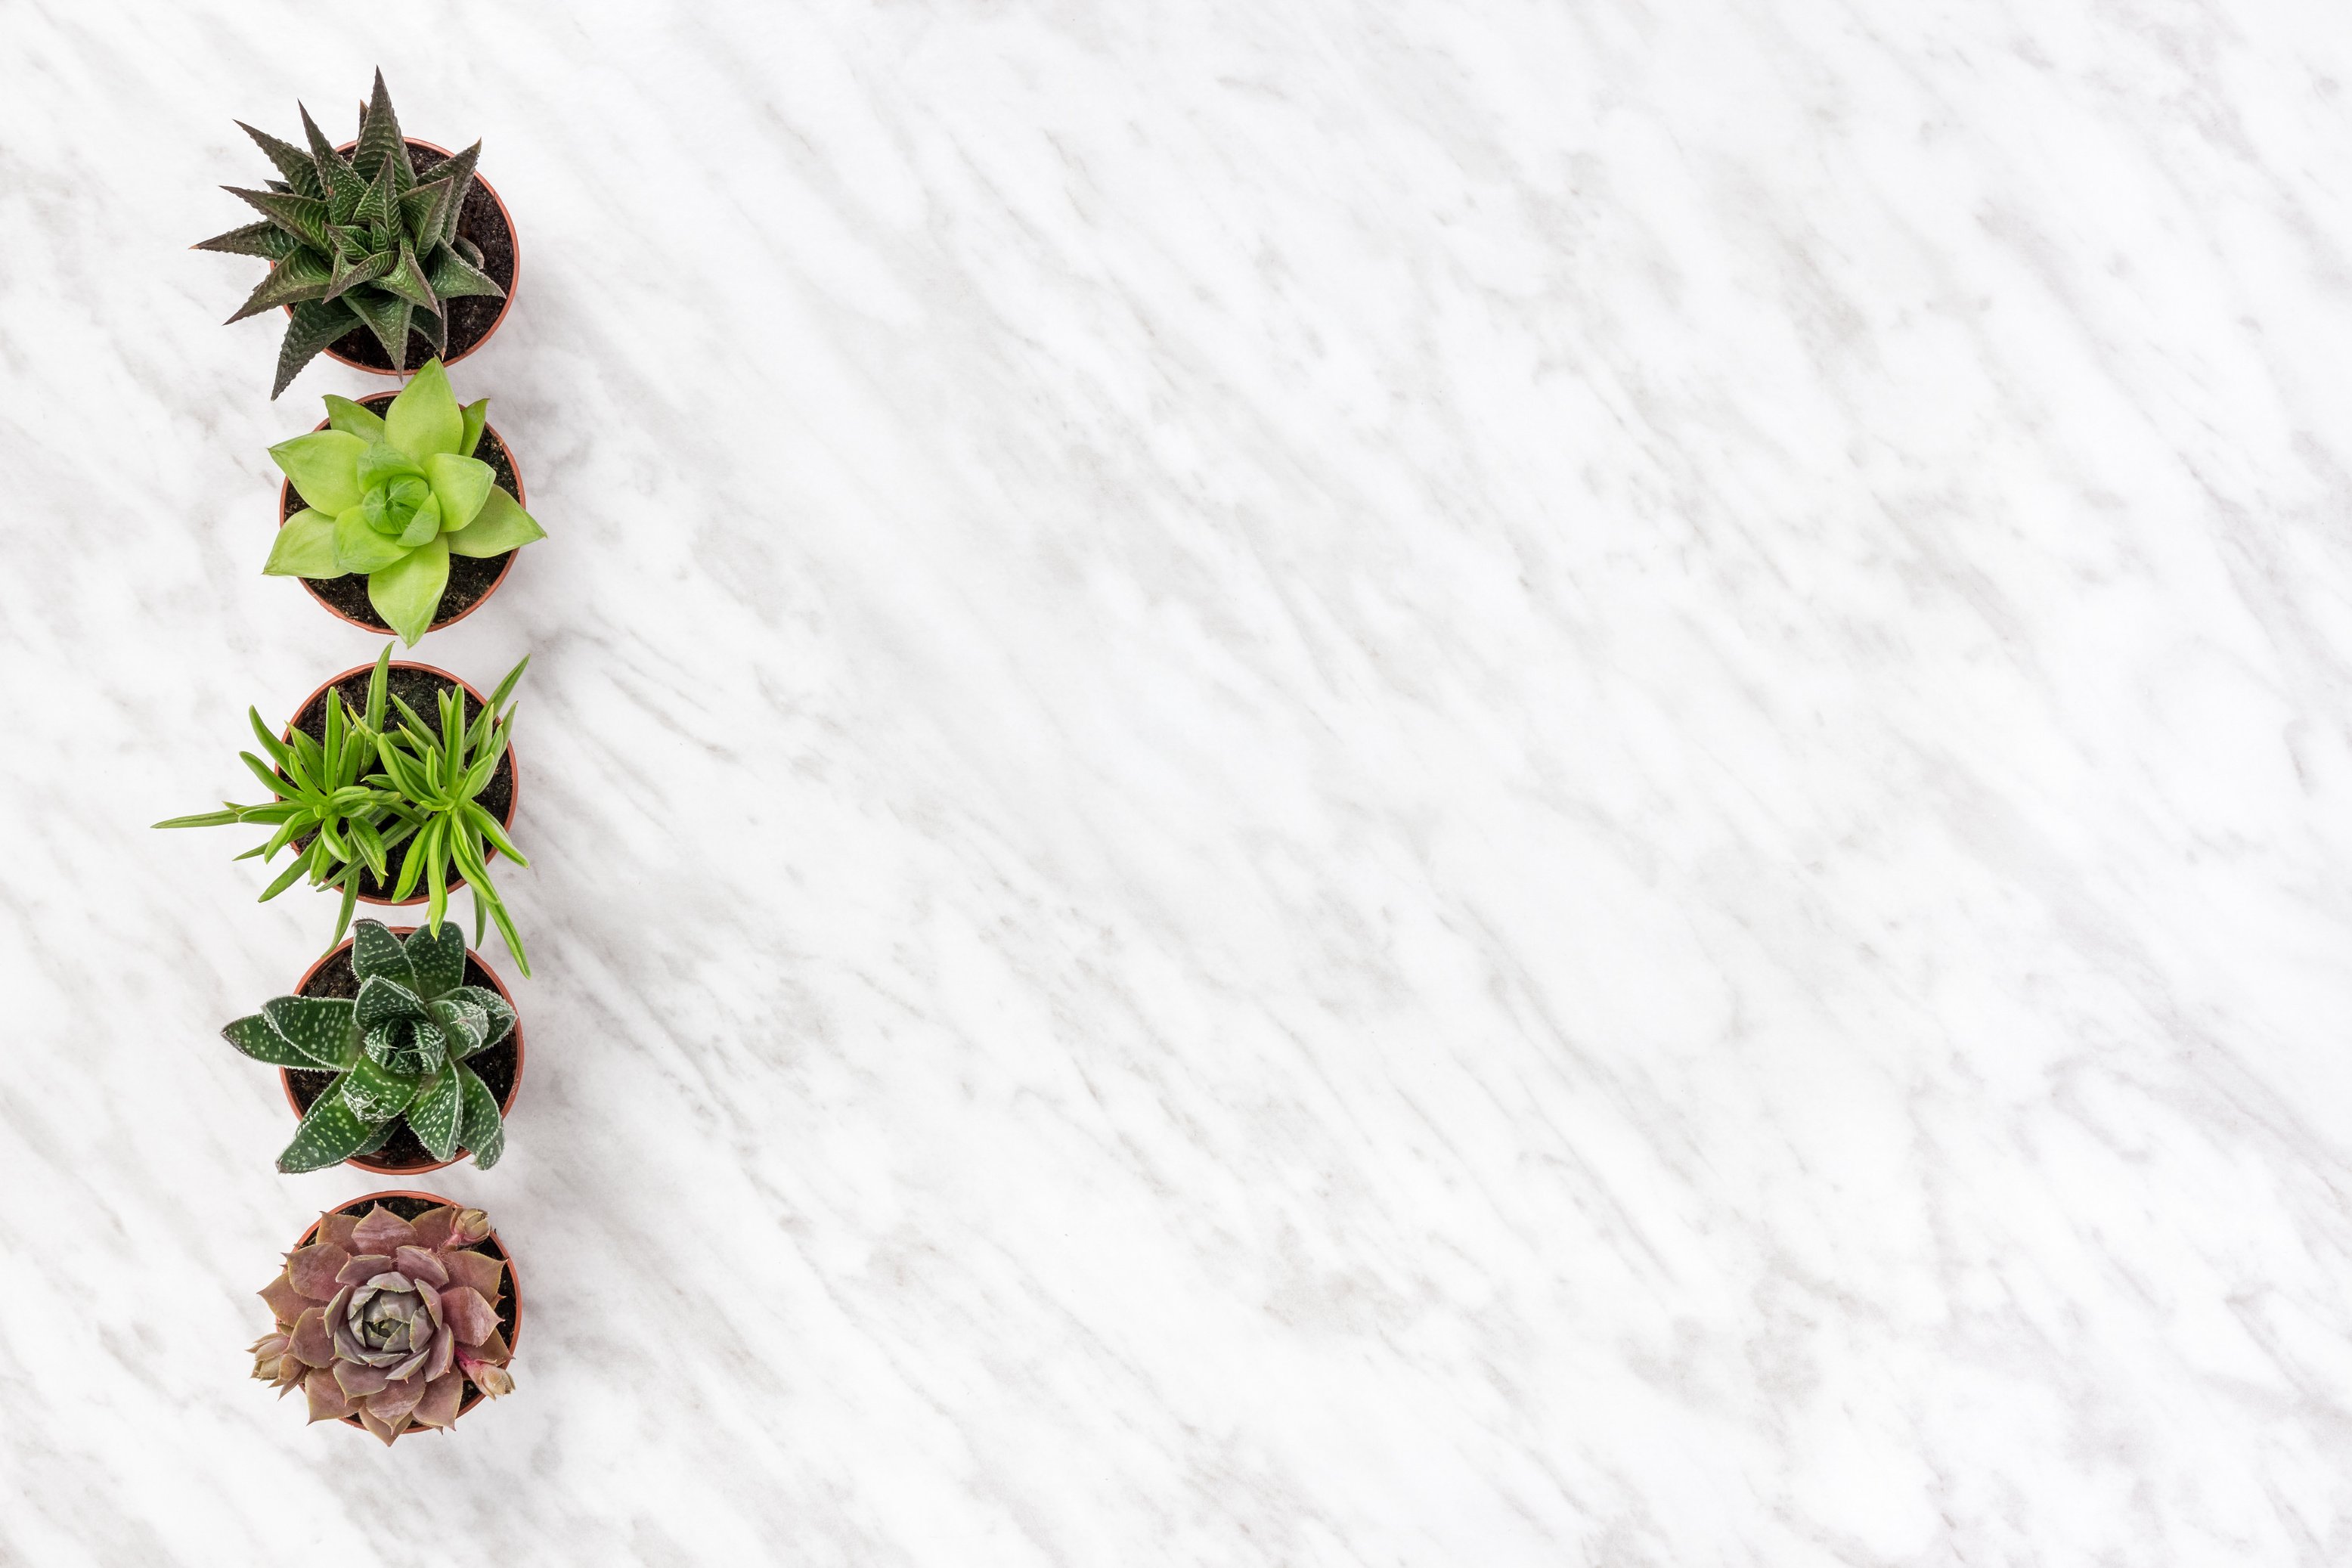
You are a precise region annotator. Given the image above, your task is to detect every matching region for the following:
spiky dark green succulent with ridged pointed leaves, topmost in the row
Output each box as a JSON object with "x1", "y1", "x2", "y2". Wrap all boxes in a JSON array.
[{"x1": 195, "y1": 70, "x2": 506, "y2": 397}]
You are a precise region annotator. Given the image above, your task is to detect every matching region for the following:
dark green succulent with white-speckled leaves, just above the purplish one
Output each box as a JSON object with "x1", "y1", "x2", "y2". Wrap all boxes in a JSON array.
[{"x1": 221, "y1": 919, "x2": 515, "y2": 1173}]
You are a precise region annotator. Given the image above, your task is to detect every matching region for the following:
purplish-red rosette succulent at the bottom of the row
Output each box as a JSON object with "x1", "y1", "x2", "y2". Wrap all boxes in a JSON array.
[{"x1": 254, "y1": 1204, "x2": 515, "y2": 1443}]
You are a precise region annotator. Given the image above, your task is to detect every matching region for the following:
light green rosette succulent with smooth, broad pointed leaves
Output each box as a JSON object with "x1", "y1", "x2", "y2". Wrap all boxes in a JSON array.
[{"x1": 263, "y1": 360, "x2": 546, "y2": 646}]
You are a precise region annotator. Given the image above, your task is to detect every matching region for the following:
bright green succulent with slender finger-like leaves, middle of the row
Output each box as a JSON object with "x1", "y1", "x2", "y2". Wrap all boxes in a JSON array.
[{"x1": 155, "y1": 644, "x2": 531, "y2": 975}]
